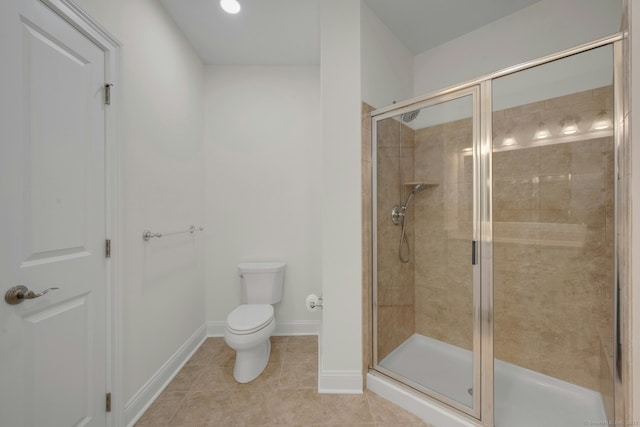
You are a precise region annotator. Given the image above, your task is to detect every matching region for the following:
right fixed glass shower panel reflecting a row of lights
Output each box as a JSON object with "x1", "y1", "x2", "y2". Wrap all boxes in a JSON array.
[{"x1": 493, "y1": 45, "x2": 615, "y2": 427}]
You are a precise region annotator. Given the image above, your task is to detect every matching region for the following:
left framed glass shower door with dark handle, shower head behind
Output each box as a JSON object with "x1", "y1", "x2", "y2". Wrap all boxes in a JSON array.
[{"x1": 373, "y1": 87, "x2": 480, "y2": 417}]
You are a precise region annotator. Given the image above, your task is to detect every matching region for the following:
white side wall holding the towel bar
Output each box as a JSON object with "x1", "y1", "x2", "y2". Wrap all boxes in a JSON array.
[{"x1": 71, "y1": 0, "x2": 205, "y2": 414}]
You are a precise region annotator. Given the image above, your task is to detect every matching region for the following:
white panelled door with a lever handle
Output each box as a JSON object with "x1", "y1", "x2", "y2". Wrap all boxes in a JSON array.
[{"x1": 0, "y1": 0, "x2": 107, "y2": 427}]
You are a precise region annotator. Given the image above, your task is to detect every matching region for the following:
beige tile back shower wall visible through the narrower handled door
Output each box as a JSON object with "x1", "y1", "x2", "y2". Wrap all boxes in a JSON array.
[{"x1": 414, "y1": 119, "x2": 473, "y2": 350}]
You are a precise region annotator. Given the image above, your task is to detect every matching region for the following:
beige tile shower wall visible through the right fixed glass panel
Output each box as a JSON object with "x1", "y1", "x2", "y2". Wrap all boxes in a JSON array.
[{"x1": 493, "y1": 87, "x2": 614, "y2": 390}]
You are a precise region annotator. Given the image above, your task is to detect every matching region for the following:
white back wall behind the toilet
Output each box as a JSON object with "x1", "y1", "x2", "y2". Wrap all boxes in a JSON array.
[{"x1": 204, "y1": 66, "x2": 322, "y2": 333}]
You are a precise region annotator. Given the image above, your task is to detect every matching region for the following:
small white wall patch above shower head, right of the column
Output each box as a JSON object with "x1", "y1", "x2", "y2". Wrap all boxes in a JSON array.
[{"x1": 360, "y1": 2, "x2": 413, "y2": 108}]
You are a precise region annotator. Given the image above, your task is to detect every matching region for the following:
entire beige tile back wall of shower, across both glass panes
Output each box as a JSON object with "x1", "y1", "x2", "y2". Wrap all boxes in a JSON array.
[{"x1": 414, "y1": 87, "x2": 614, "y2": 392}]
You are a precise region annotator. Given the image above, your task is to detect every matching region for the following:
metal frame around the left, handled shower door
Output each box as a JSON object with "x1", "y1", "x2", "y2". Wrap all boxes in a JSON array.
[{"x1": 371, "y1": 84, "x2": 486, "y2": 420}]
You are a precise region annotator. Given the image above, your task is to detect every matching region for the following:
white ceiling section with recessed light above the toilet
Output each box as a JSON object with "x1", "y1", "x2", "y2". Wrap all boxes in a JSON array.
[{"x1": 160, "y1": 0, "x2": 320, "y2": 65}]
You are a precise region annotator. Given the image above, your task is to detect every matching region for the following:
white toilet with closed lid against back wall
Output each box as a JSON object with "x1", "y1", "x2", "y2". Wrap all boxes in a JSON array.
[{"x1": 224, "y1": 262, "x2": 287, "y2": 383}]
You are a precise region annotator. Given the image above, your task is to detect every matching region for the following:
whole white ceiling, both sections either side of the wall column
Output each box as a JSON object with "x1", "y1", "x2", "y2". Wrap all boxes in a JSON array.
[{"x1": 160, "y1": 0, "x2": 540, "y2": 65}]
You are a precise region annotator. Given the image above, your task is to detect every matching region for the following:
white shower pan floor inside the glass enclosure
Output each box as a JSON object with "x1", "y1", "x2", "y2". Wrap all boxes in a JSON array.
[{"x1": 380, "y1": 334, "x2": 607, "y2": 427}]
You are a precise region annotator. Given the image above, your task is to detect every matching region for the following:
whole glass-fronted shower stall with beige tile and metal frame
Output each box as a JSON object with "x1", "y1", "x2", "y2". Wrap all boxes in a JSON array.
[{"x1": 369, "y1": 36, "x2": 624, "y2": 427}]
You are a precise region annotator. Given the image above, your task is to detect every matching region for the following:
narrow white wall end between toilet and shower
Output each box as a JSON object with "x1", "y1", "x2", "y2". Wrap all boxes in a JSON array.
[{"x1": 318, "y1": 0, "x2": 362, "y2": 392}]
